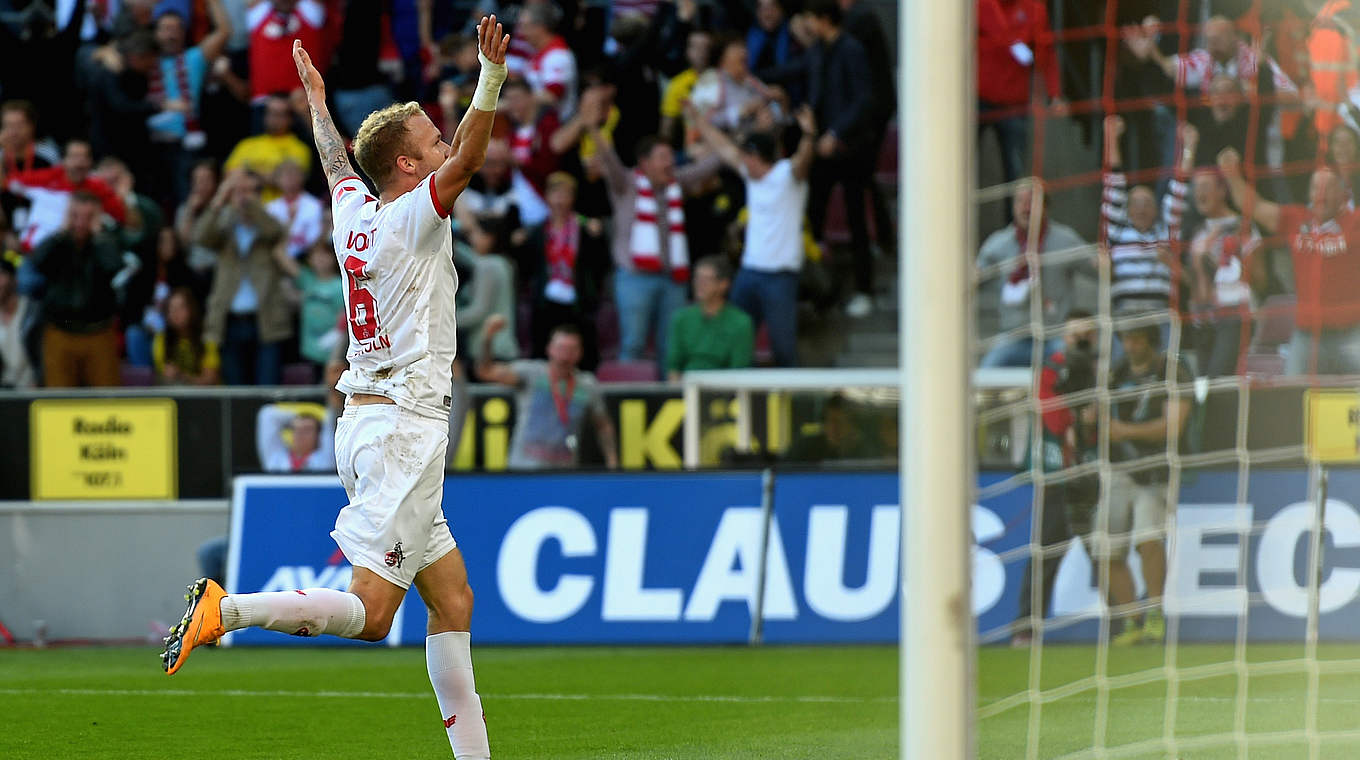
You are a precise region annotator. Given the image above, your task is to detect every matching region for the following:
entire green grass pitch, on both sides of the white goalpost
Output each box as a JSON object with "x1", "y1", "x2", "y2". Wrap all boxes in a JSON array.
[{"x1": 0, "y1": 644, "x2": 1360, "y2": 760}]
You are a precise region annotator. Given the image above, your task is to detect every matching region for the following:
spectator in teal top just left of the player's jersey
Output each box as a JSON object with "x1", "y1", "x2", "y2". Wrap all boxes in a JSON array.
[{"x1": 273, "y1": 238, "x2": 348, "y2": 370}]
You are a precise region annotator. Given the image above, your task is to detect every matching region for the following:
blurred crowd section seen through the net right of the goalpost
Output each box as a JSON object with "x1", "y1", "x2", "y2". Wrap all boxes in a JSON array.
[{"x1": 976, "y1": 0, "x2": 1360, "y2": 378}]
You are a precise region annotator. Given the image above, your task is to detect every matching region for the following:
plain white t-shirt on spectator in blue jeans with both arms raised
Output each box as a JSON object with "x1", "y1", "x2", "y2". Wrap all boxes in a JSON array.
[{"x1": 741, "y1": 159, "x2": 808, "y2": 272}]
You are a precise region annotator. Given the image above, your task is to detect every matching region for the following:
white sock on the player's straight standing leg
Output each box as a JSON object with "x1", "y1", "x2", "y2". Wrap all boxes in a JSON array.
[{"x1": 426, "y1": 631, "x2": 491, "y2": 760}]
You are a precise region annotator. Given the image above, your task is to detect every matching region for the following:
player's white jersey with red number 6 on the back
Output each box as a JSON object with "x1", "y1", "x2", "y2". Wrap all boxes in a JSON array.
[{"x1": 330, "y1": 174, "x2": 458, "y2": 420}]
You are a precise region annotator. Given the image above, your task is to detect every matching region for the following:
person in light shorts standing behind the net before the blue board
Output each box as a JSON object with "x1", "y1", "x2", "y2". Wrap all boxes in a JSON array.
[{"x1": 1083, "y1": 325, "x2": 1191, "y2": 644}]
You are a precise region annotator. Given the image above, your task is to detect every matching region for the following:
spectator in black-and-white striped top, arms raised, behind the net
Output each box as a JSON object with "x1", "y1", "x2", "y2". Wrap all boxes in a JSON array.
[{"x1": 1100, "y1": 116, "x2": 1194, "y2": 320}]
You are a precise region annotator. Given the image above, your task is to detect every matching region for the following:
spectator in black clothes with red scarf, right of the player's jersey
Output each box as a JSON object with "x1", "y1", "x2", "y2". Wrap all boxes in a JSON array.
[{"x1": 525, "y1": 171, "x2": 609, "y2": 370}]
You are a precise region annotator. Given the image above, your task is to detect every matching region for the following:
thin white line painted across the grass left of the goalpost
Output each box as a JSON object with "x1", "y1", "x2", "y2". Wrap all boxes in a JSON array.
[{"x1": 0, "y1": 688, "x2": 898, "y2": 704}]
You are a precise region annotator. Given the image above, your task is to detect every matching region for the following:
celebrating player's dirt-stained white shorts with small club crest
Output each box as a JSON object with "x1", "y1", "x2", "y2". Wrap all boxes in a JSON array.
[{"x1": 330, "y1": 404, "x2": 457, "y2": 589}]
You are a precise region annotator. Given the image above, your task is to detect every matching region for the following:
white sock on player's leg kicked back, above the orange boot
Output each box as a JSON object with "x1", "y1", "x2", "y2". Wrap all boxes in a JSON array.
[{"x1": 222, "y1": 589, "x2": 364, "y2": 639}]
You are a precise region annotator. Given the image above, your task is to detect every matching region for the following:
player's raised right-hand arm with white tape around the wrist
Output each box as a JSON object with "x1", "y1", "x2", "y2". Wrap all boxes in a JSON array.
[{"x1": 434, "y1": 16, "x2": 510, "y2": 208}]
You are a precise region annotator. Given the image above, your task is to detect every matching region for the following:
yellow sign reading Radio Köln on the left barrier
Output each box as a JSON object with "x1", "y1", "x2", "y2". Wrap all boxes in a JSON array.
[{"x1": 29, "y1": 398, "x2": 180, "y2": 500}]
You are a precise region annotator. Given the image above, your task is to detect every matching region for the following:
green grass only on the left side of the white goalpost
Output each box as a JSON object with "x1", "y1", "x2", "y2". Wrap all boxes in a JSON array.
[{"x1": 0, "y1": 647, "x2": 898, "y2": 760}]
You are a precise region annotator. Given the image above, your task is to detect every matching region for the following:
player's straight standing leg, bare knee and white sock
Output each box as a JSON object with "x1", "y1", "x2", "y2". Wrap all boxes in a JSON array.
[{"x1": 416, "y1": 546, "x2": 491, "y2": 760}]
